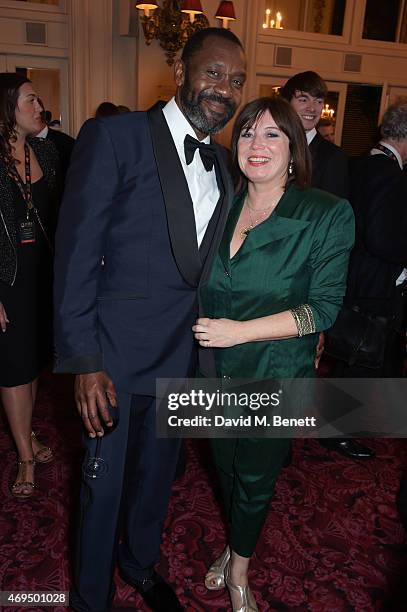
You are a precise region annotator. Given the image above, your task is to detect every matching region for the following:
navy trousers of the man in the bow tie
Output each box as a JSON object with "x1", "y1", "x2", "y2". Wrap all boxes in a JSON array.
[{"x1": 70, "y1": 393, "x2": 180, "y2": 612}]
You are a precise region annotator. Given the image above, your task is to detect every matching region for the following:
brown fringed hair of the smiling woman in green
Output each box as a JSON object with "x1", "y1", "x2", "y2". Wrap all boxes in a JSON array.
[{"x1": 232, "y1": 96, "x2": 311, "y2": 193}]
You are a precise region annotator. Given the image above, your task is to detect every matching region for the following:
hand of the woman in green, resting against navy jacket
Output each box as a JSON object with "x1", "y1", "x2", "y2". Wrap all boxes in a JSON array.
[{"x1": 192, "y1": 318, "x2": 245, "y2": 348}]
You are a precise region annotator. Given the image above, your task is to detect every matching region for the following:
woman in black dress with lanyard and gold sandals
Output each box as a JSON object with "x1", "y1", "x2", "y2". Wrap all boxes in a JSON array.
[{"x1": 0, "y1": 73, "x2": 58, "y2": 499}]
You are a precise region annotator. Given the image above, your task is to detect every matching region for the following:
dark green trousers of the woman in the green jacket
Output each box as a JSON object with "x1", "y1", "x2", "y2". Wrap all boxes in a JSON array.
[{"x1": 211, "y1": 438, "x2": 290, "y2": 557}]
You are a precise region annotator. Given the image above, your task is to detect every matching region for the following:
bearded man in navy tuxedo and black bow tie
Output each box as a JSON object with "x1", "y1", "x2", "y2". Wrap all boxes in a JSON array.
[{"x1": 55, "y1": 28, "x2": 245, "y2": 612}]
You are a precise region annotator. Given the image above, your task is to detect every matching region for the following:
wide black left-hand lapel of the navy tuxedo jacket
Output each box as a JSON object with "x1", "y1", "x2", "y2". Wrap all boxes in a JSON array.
[{"x1": 147, "y1": 103, "x2": 201, "y2": 287}]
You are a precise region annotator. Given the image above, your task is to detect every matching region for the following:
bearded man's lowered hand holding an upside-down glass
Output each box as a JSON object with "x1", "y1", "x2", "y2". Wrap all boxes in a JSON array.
[{"x1": 75, "y1": 371, "x2": 117, "y2": 438}]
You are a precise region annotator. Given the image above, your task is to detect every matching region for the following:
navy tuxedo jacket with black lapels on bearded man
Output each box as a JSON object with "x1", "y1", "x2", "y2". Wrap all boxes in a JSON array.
[{"x1": 55, "y1": 104, "x2": 233, "y2": 395}]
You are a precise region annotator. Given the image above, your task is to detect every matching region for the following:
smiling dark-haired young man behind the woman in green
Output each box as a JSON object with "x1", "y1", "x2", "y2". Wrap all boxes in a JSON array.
[{"x1": 280, "y1": 70, "x2": 349, "y2": 198}]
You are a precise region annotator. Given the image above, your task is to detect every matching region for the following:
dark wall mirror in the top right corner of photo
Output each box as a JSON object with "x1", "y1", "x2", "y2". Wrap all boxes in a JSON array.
[{"x1": 362, "y1": 0, "x2": 407, "y2": 43}]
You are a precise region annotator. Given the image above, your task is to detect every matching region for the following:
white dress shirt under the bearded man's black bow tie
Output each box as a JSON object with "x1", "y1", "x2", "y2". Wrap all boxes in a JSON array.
[{"x1": 163, "y1": 98, "x2": 220, "y2": 247}]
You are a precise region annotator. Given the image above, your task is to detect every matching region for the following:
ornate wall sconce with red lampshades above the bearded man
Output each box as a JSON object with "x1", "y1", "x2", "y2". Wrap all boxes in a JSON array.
[{"x1": 136, "y1": 0, "x2": 236, "y2": 66}]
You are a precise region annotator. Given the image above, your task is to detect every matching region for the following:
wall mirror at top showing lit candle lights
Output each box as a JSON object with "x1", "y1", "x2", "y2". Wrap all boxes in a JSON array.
[{"x1": 263, "y1": 0, "x2": 346, "y2": 36}]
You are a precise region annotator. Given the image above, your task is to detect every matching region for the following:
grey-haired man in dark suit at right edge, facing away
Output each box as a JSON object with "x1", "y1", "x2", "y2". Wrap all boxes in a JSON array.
[{"x1": 340, "y1": 101, "x2": 407, "y2": 378}]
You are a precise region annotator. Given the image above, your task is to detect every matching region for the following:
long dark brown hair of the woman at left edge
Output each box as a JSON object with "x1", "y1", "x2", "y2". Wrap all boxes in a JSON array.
[{"x1": 0, "y1": 72, "x2": 31, "y2": 166}]
